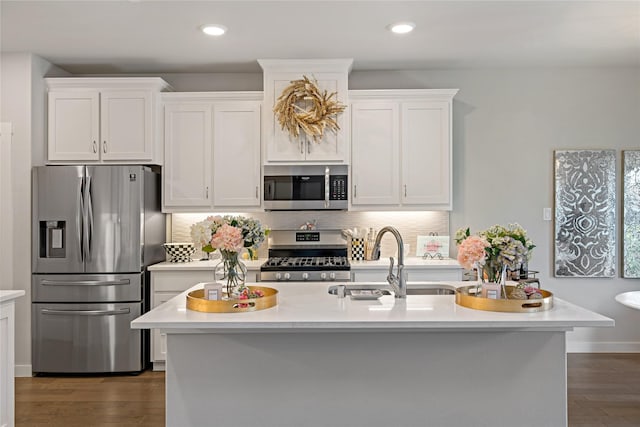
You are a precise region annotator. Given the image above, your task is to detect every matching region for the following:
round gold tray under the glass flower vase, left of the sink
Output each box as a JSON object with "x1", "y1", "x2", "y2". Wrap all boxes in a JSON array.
[{"x1": 187, "y1": 286, "x2": 278, "y2": 313}]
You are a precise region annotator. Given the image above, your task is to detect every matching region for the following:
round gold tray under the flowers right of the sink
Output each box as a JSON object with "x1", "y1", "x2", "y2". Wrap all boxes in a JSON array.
[{"x1": 456, "y1": 285, "x2": 553, "y2": 313}]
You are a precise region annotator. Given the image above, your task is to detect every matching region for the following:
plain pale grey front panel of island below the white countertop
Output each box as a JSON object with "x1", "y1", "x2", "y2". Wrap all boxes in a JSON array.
[{"x1": 166, "y1": 331, "x2": 567, "y2": 427}]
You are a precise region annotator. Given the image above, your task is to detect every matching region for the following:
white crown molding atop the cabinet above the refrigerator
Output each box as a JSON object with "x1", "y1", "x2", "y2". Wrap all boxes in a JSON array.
[{"x1": 45, "y1": 77, "x2": 173, "y2": 92}]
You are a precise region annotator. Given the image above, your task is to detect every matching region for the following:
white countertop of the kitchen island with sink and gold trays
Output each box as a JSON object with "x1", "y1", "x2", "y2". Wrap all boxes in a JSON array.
[{"x1": 131, "y1": 282, "x2": 614, "y2": 333}]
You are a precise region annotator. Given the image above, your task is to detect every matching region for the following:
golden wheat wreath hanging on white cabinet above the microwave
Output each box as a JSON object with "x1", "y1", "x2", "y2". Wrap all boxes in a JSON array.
[{"x1": 273, "y1": 76, "x2": 346, "y2": 142}]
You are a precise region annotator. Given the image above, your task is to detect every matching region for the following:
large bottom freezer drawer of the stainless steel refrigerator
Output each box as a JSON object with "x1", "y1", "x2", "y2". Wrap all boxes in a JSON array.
[{"x1": 31, "y1": 303, "x2": 146, "y2": 373}]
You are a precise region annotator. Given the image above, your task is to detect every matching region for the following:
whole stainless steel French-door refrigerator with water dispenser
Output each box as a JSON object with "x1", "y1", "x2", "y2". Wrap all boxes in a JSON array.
[{"x1": 31, "y1": 165, "x2": 165, "y2": 373}]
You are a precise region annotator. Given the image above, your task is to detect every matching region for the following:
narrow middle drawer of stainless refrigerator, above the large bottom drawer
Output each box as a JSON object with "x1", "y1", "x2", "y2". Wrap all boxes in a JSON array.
[{"x1": 31, "y1": 273, "x2": 144, "y2": 303}]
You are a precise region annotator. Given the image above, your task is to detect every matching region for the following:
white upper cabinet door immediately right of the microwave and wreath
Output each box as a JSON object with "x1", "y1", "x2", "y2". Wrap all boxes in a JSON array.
[{"x1": 351, "y1": 102, "x2": 400, "y2": 206}]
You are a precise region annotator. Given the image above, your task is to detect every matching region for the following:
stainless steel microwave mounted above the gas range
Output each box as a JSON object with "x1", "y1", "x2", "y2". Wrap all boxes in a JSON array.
[{"x1": 264, "y1": 167, "x2": 349, "y2": 210}]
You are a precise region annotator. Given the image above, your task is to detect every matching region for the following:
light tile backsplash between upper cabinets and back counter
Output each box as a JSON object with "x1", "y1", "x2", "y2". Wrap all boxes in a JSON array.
[{"x1": 167, "y1": 211, "x2": 449, "y2": 258}]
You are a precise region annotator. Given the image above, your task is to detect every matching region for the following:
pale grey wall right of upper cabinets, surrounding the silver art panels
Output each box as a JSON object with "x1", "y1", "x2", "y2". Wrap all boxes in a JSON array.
[{"x1": 349, "y1": 68, "x2": 640, "y2": 352}]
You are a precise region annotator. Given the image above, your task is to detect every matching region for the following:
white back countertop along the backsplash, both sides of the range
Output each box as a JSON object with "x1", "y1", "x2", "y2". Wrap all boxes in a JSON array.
[{"x1": 149, "y1": 257, "x2": 462, "y2": 271}]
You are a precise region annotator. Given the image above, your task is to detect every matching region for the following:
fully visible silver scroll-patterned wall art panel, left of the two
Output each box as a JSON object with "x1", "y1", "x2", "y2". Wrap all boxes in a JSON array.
[{"x1": 555, "y1": 150, "x2": 616, "y2": 277}]
